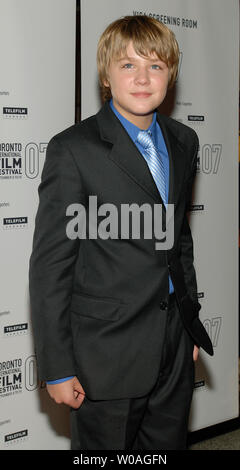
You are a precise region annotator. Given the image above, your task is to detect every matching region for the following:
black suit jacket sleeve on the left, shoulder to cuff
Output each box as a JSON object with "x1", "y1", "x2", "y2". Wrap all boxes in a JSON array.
[{"x1": 29, "y1": 137, "x2": 84, "y2": 381}]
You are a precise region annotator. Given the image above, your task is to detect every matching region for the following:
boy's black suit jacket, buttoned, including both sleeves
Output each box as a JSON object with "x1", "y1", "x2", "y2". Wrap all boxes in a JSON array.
[{"x1": 29, "y1": 103, "x2": 213, "y2": 399}]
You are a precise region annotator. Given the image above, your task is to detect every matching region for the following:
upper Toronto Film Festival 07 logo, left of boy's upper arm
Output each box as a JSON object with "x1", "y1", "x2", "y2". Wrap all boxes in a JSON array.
[{"x1": 0, "y1": 142, "x2": 47, "y2": 180}]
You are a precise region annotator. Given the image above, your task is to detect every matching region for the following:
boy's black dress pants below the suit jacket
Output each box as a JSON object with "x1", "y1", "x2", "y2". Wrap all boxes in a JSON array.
[{"x1": 71, "y1": 295, "x2": 194, "y2": 451}]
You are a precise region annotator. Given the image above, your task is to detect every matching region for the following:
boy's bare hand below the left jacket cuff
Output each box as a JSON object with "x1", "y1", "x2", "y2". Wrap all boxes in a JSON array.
[{"x1": 47, "y1": 377, "x2": 85, "y2": 409}]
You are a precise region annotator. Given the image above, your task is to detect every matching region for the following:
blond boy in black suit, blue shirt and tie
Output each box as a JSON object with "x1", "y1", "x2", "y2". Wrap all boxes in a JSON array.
[{"x1": 30, "y1": 16, "x2": 213, "y2": 450}]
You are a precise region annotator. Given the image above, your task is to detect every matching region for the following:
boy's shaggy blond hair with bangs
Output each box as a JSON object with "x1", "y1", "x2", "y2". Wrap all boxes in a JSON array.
[{"x1": 97, "y1": 15, "x2": 179, "y2": 101}]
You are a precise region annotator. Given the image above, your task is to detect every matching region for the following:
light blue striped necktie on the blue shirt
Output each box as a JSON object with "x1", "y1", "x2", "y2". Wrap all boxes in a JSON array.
[{"x1": 137, "y1": 131, "x2": 167, "y2": 205}]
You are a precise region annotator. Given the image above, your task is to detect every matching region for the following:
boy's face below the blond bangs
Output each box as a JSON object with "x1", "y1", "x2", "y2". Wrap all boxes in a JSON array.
[{"x1": 104, "y1": 42, "x2": 169, "y2": 129}]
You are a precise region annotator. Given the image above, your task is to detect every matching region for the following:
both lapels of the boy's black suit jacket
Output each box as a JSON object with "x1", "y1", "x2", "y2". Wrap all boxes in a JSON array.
[{"x1": 97, "y1": 103, "x2": 185, "y2": 208}]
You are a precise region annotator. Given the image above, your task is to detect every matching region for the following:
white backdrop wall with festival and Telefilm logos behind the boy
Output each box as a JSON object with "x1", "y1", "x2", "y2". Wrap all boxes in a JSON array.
[{"x1": 0, "y1": 0, "x2": 238, "y2": 450}]
